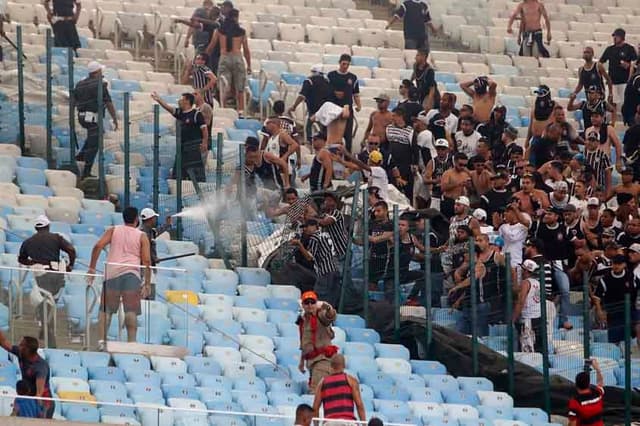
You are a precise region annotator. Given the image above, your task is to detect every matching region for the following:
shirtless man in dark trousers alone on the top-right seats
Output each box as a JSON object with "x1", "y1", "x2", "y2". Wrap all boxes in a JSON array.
[{"x1": 507, "y1": 0, "x2": 551, "y2": 58}]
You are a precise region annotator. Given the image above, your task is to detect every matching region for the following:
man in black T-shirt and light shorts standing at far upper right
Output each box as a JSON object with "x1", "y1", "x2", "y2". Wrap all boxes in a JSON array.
[{"x1": 600, "y1": 28, "x2": 638, "y2": 107}]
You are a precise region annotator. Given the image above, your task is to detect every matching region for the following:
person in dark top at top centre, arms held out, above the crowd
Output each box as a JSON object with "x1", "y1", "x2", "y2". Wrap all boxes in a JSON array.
[{"x1": 386, "y1": 0, "x2": 438, "y2": 55}]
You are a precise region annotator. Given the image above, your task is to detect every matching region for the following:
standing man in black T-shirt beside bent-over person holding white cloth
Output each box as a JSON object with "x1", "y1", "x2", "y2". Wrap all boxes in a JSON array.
[{"x1": 327, "y1": 53, "x2": 362, "y2": 152}]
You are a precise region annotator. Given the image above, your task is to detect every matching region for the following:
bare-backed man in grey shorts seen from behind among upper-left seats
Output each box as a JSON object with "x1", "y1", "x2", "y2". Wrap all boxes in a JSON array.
[{"x1": 207, "y1": 9, "x2": 251, "y2": 117}]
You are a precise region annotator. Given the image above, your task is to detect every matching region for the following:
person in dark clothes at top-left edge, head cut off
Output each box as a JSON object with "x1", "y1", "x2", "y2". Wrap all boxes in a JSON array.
[{"x1": 44, "y1": 0, "x2": 82, "y2": 50}]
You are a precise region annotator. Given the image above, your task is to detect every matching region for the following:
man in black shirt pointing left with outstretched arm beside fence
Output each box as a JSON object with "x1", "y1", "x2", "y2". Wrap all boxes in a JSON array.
[{"x1": 151, "y1": 92, "x2": 209, "y2": 182}]
